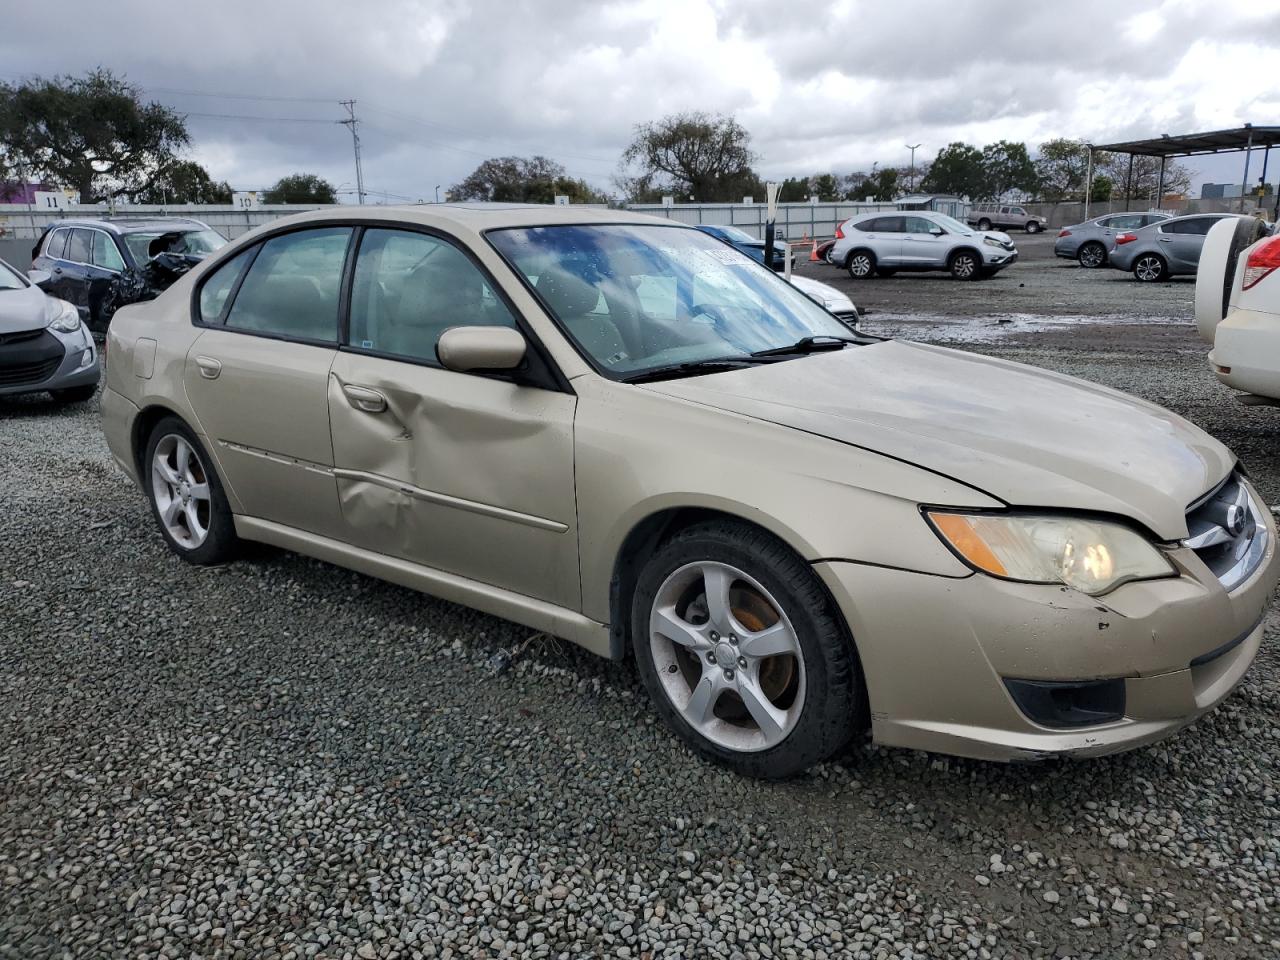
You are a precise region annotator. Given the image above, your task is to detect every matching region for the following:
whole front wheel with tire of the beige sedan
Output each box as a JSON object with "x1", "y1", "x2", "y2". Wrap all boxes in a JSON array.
[{"x1": 631, "y1": 521, "x2": 865, "y2": 780}]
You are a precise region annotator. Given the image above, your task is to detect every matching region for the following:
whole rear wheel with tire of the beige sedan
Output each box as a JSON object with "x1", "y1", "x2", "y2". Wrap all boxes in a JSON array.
[{"x1": 141, "y1": 417, "x2": 239, "y2": 566}]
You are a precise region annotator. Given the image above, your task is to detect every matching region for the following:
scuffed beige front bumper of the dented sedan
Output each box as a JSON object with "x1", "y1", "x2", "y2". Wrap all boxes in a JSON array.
[{"x1": 815, "y1": 499, "x2": 1280, "y2": 760}]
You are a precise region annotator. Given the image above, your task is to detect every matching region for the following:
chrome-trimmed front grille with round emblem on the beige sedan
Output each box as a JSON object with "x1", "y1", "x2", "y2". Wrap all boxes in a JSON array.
[{"x1": 1183, "y1": 474, "x2": 1267, "y2": 590}]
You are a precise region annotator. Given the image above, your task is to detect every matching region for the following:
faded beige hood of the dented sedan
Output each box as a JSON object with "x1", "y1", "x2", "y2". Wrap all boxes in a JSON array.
[{"x1": 643, "y1": 340, "x2": 1235, "y2": 540}]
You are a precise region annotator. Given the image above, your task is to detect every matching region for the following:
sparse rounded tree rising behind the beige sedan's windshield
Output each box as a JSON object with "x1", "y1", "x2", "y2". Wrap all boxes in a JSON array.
[{"x1": 621, "y1": 111, "x2": 760, "y2": 202}]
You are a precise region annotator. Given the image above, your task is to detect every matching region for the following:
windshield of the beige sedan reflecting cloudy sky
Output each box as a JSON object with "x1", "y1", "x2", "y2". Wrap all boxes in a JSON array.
[{"x1": 486, "y1": 224, "x2": 849, "y2": 379}]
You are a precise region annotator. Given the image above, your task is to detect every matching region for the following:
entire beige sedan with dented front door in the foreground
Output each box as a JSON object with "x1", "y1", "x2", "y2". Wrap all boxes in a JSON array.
[{"x1": 102, "y1": 204, "x2": 1280, "y2": 777}]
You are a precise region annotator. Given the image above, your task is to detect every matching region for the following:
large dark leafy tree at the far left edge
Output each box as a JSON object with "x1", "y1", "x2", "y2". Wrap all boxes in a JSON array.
[{"x1": 0, "y1": 69, "x2": 189, "y2": 204}]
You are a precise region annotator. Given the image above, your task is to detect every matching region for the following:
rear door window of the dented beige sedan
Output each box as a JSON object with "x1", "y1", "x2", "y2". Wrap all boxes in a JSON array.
[{"x1": 227, "y1": 227, "x2": 351, "y2": 343}]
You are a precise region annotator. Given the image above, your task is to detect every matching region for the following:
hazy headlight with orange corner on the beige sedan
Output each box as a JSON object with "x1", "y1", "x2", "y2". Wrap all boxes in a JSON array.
[{"x1": 928, "y1": 511, "x2": 1176, "y2": 596}]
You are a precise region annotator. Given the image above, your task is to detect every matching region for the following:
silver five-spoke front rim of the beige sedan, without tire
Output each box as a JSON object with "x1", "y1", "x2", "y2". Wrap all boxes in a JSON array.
[{"x1": 649, "y1": 561, "x2": 805, "y2": 753}]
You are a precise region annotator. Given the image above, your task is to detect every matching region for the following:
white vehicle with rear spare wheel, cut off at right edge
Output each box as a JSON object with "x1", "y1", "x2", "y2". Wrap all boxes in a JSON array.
[{"x1": 1196, "y1": 218, "x2": 1280, "y2": 406}]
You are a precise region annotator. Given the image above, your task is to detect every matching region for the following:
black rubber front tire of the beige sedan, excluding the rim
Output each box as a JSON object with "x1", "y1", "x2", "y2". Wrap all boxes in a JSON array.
[{"x1": 631, "y1": 520, "x2": 867, "y2": 780}]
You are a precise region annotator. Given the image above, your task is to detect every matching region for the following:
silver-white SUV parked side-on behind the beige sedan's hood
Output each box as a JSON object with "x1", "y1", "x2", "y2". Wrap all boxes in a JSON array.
[{"x1": 828, "y1": 211, "x2": 1018, "y2": 280}]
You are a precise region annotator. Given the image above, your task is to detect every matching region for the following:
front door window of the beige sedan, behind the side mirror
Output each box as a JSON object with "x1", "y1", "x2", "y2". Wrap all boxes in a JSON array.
[{"x1": 348, "y1": 229, "x2": 516, "y2": 364}]
